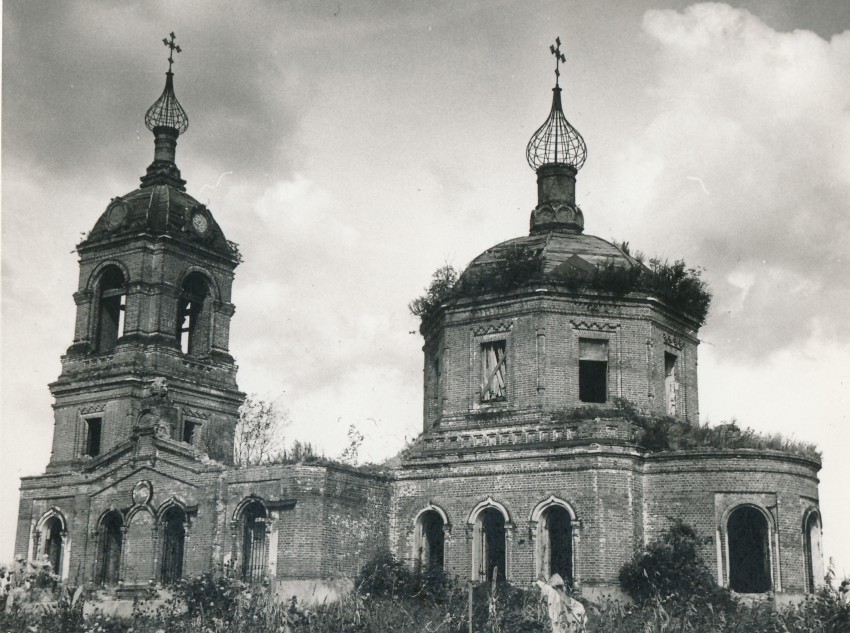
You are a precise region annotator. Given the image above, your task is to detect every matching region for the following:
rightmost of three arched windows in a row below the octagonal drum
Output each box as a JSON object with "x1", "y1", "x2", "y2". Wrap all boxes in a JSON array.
[{"x1": 531, "y1": 496, "x2": 578, "y2": 585}]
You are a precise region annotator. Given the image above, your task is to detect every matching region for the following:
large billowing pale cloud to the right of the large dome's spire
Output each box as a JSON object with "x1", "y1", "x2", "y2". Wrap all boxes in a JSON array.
[{"x1": 614, "y1": 4, "x2": 850, "y2": 358}]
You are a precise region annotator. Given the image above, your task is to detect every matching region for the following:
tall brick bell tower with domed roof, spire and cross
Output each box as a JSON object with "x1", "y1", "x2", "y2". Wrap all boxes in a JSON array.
[{"x1": 47, "y1": 33, "x2": 244, "y2": 472}]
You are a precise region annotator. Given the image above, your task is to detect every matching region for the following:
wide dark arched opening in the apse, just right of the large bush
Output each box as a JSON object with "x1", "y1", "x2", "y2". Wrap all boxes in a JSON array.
[{"x1": 727, "y1": 506, "x2": 771, "y2": 593}]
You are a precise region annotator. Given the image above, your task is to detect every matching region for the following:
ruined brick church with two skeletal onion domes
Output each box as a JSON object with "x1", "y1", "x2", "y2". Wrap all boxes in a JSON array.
[{"x1": 15, "y1": 41, "x2": 823, "y2": 595}]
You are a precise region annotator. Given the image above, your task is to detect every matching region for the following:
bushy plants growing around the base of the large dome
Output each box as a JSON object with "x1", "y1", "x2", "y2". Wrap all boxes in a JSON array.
[{"x1": 409, "y1": 243, "x2": 711, "y2": 324}]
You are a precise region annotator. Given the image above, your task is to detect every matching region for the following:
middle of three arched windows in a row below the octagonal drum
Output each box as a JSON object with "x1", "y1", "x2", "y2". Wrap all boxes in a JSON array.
[{"x1": 469, "y1": 497, "x2": 511, "y2": 582}]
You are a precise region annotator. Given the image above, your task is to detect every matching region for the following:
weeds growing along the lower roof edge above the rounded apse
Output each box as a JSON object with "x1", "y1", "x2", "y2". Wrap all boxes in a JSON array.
[{"x1": 552, "y1": 398, "x2": 822, "y2": 460}]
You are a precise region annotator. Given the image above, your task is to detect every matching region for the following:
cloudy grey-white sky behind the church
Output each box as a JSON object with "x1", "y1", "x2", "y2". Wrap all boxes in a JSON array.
[{"x1": 0, "y1": 0, "x2": 850, "y2": 576}]
